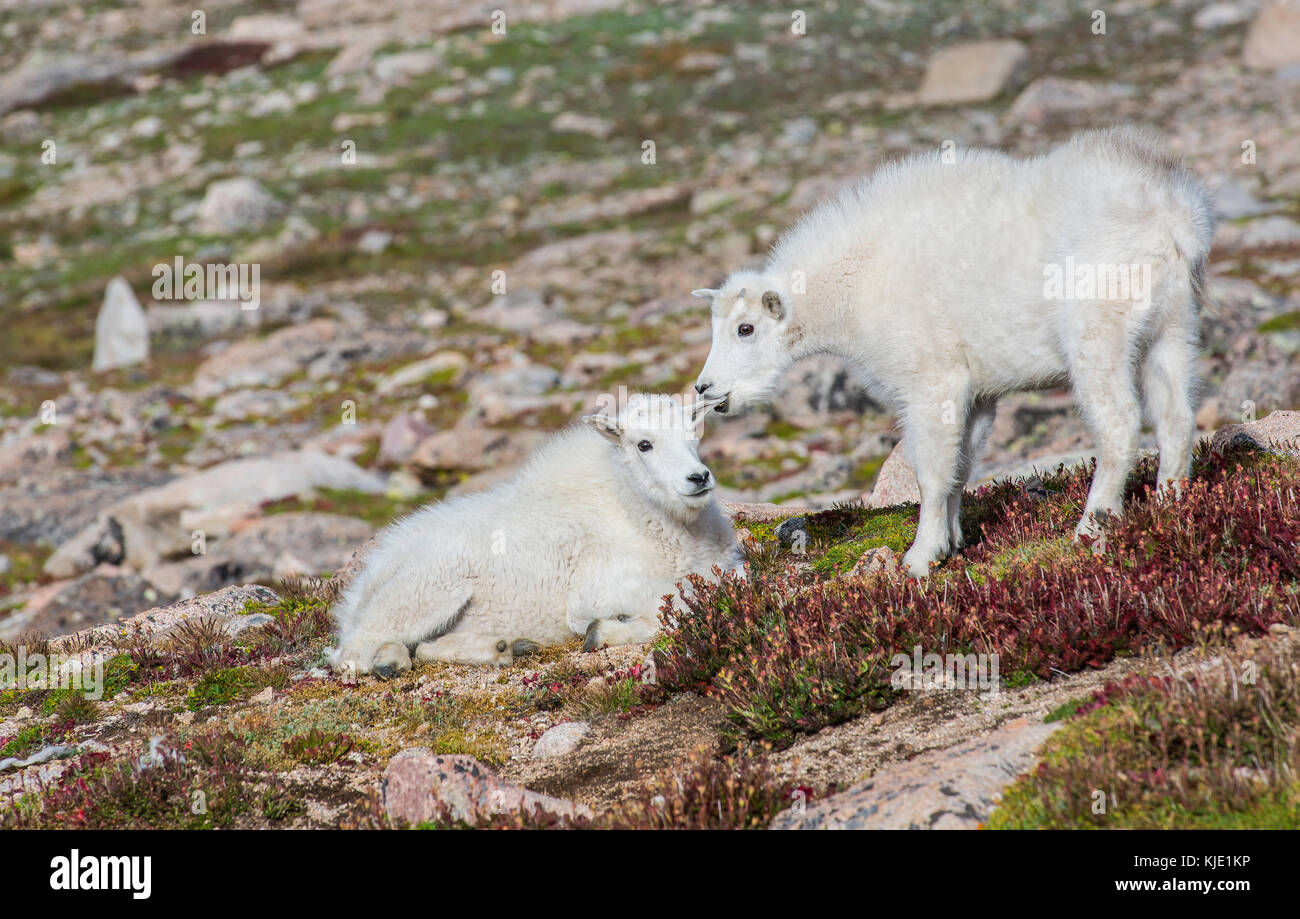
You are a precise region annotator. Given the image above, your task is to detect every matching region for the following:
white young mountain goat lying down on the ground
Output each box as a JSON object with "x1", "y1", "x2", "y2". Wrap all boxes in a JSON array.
[{"x1": 333, "y1": 394, "x2": 744, "y2": 676}]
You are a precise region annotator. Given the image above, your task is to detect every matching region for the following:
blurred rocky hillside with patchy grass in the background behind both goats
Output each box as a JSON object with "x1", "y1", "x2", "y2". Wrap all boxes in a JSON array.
[{"x1": 0, "y1": 0, "x2": 1300, "y2": 637}]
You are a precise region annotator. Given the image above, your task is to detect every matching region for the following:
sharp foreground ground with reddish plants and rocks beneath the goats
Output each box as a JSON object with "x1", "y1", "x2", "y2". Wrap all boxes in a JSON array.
[{"x1": 0, "y1": 413, "x2": 1300, "y2": 828}]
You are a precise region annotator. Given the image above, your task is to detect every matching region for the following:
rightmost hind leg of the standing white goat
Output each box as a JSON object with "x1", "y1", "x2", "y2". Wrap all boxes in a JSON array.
[{"x1": 1141, "y1": 328, "x2": 1196, "y2": 495}]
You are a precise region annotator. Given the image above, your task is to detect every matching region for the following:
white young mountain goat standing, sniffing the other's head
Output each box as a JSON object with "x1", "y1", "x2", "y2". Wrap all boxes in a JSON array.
[{"x1": 694, "y1": 130, "x2": 1213, "y2": 577}]
